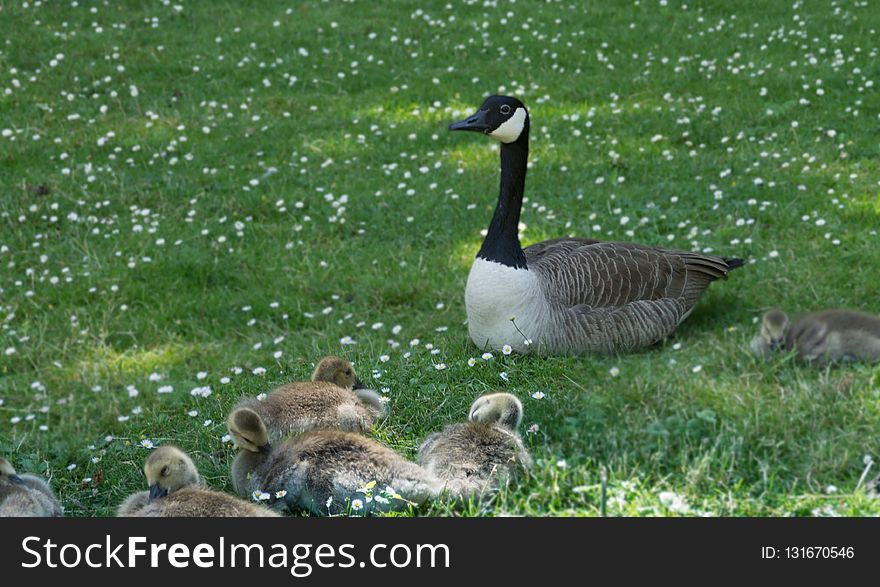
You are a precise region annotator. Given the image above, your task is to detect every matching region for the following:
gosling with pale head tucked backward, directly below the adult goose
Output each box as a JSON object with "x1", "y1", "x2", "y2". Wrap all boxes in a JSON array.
[{"x1": 419, "y1": 393, "x2": 532, "y2": 499}]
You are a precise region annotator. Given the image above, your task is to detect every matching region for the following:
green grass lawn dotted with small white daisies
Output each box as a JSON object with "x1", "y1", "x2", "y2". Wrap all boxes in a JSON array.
[{"x1": 0, "y1": 0, "x2": 880, "y2": 516}]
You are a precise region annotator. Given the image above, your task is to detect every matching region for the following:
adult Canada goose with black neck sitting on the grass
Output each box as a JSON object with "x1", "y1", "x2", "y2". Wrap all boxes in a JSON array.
[{"x1": 449, "y1": 96, "x2": 743, "y2": 354}]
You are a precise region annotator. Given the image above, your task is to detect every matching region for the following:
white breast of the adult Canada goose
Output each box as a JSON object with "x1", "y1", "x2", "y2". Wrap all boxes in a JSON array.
[{"x1": 464, "y1": 258, "x2": 547, "y2": 352}]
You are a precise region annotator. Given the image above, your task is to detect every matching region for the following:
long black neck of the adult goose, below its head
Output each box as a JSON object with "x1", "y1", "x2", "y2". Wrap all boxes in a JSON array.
[{"x1": 477, "y1": 131, "x2": 529, "y2": 269}]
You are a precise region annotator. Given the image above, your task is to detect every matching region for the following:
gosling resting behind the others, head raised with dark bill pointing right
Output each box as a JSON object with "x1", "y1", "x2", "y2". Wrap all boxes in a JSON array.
[{"x1": 236, "y1": 356, "x2": 386, "y2": 440}]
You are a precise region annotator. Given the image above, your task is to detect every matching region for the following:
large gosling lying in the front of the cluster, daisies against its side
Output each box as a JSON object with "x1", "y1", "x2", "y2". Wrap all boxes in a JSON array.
[{"x1": 227, "y1": 408, "x2": 442, "y2": 515}]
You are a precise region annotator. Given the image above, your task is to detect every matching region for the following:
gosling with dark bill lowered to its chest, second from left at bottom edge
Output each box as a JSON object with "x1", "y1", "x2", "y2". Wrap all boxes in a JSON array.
[{"x1": 117, "y1": 445, "x2": 278, "y2": 518}]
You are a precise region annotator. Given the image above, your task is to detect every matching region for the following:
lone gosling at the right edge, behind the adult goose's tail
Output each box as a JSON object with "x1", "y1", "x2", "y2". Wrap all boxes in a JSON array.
[{"x1": 751, "y1": 309, "x2": 880, "y2": 365}]
